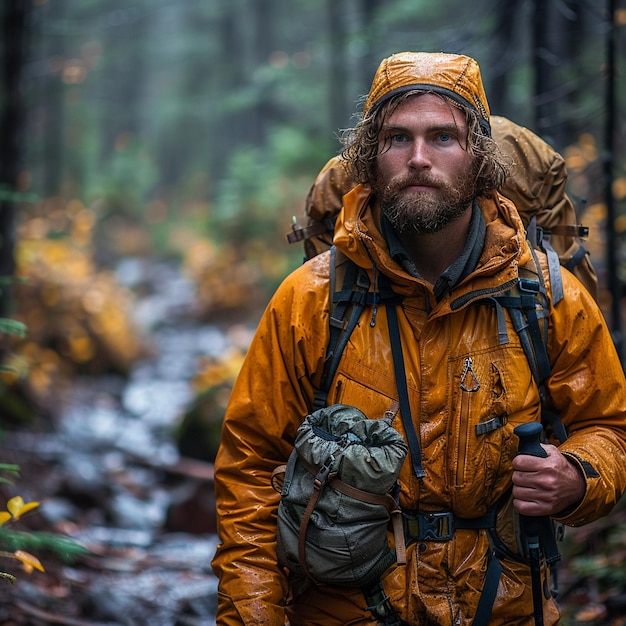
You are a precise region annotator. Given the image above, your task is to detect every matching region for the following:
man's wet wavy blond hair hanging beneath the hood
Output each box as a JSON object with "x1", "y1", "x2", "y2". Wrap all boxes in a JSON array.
[{"x1": 341, "y1": 90, "x2": 510, "y2": 196}]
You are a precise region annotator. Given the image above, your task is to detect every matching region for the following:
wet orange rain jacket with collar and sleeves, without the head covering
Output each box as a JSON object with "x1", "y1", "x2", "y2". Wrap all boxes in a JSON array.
[{"x1": 213, "y1": 180, "x2": 626, "y2": 626}]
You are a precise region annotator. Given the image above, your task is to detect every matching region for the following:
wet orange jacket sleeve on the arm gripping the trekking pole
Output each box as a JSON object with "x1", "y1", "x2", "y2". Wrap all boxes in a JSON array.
[{"x1": 547, "y1": 270, "x2": 626, "y2": 526}]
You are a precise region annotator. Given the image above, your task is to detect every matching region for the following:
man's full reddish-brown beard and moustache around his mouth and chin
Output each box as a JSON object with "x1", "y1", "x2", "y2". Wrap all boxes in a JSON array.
[{"x1": 374, "y1": 168, "x2": 476, "y2": 234}]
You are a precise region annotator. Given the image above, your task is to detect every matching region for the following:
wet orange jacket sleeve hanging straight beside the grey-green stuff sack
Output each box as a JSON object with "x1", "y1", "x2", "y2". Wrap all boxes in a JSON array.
[{"x1": 213, "y1": 255, "x2": 328, "y2": 626}]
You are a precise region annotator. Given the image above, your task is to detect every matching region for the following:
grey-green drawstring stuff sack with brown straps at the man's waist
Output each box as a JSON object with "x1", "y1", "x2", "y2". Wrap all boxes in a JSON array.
[{"x1": 273, "y1": 405, "x2": 407, "y2": 587}]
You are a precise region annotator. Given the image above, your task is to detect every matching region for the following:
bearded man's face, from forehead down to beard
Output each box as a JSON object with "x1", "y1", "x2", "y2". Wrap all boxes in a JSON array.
[{"x1": 373, "y1": 94, "x2": 477, "y2": 234}]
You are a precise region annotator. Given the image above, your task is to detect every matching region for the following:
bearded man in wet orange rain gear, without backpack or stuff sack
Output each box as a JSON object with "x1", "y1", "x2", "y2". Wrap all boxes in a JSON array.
[{"x1": 213, "y1": 53, "x2": 626, "y2": 626}]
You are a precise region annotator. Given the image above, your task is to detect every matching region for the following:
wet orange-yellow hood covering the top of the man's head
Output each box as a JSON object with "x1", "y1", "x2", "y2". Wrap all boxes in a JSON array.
[{"x1": 363, "y1": 52, "x2": 490, "y2": 135}]
